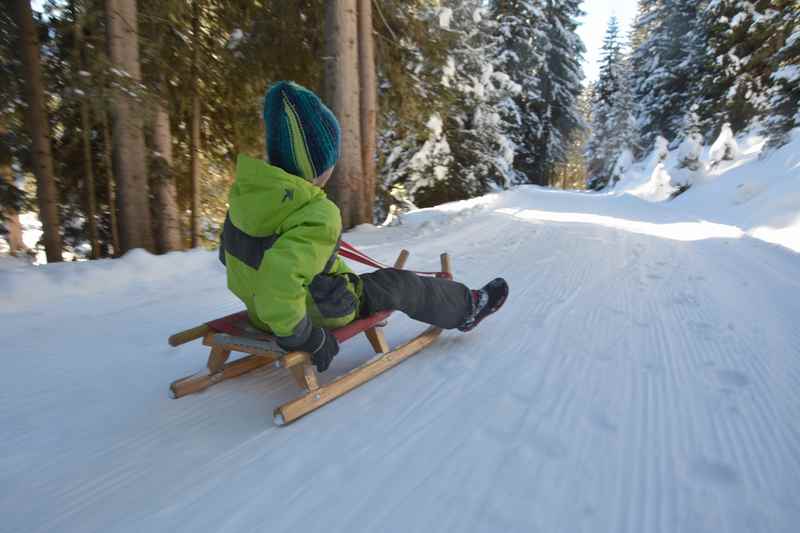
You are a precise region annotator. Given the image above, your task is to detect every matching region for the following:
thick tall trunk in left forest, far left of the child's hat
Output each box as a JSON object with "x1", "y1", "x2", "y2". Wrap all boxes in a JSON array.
[{"x1": 106, "y1": 0, "x2": 153, "y2": 253}]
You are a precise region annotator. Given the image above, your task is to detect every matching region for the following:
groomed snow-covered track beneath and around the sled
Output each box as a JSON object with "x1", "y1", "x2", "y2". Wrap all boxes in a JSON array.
[{"x1": 0, "y1": 182, "x2": 800, "y2": 533}]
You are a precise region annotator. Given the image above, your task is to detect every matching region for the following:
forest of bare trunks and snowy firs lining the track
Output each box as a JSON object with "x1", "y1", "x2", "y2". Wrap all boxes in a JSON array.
[{"x1": 0, "y1": 0, "x2": 800, "y2": 262}]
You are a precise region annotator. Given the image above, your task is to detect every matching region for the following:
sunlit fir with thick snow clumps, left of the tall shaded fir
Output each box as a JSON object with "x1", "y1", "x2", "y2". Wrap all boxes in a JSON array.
[{"x1": 406, "y1": 0, "x2": 523, "y2": 206}]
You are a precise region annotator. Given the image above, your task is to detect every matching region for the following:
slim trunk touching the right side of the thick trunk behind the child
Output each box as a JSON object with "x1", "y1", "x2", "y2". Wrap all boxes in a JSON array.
[{"x1": 358, "y1": 0, "x2": 378, "y2": 222}]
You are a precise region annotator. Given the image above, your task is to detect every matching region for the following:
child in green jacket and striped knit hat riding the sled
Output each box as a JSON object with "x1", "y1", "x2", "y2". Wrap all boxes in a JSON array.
[{"x1": 220, "y1": 81, "x2": 508, "y2": 372}]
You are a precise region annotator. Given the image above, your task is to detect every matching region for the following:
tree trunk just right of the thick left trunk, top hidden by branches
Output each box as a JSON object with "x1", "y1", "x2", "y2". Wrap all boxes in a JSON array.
[{"x1": 153, "y1": 94, "x2": 182, "y2": 253}]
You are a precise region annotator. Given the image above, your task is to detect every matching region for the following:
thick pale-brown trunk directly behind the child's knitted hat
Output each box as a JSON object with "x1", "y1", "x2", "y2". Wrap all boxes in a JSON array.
[{"x1": 324, "y1": 0, "x2": 366, "y2": 229}]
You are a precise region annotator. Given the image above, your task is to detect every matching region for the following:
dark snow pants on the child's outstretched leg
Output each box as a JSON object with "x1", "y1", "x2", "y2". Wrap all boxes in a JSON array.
[{"x1": 360, "y1": 268, "x2": 472, "y2": 329}]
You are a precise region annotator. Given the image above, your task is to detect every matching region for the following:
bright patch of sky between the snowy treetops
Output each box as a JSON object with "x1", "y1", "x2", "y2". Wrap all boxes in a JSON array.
[{"x1": 578, "y1": 0, "x2": 638, "y2": 83}]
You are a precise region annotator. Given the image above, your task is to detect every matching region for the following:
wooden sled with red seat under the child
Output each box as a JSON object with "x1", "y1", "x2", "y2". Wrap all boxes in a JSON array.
[{"x1": 169, "y1": 250, "x2": 452, "y2": 426}]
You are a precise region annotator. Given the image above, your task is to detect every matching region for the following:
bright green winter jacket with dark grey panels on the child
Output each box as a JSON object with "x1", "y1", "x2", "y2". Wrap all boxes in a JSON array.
[{"x1": 220, "y1": 155, "x2": 361, "y2": 344}]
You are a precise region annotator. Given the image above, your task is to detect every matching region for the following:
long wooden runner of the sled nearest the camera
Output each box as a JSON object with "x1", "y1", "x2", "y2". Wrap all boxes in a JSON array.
[{"x1": 273, "y1": 327, "x2": 442, "y2": 426}]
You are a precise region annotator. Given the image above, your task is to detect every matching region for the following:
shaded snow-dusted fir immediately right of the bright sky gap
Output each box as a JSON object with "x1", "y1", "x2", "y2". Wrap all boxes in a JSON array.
[{"x1": 631, "y1": 0, "x2": 706, "y2": 156}]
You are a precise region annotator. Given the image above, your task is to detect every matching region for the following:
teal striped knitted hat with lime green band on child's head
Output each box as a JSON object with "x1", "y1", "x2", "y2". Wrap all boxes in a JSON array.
[{"x1": 264, "y1": 81, "x2": 341, "y2": 181}]
